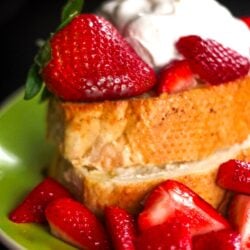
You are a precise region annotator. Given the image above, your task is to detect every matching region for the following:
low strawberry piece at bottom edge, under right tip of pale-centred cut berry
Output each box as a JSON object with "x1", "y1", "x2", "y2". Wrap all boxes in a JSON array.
[{"x1": 192, "y1": 229, "x2": 241, "y2": 250}]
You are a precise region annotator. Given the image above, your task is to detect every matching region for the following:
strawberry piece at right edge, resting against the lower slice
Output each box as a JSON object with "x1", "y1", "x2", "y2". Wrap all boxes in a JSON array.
[{"x1": 217, "y1": 160, "x2": 250, "y2": 194}]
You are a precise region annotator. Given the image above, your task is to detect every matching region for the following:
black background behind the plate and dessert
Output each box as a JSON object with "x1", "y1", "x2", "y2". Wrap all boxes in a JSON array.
[{"x1": 0, "y1": 0, "x2": 250, "y2": 102}]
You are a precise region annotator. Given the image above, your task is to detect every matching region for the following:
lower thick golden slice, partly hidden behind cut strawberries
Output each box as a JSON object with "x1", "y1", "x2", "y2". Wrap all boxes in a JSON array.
[{"x1": 49, "y1": 137, "x2": 250, "y2": 215}]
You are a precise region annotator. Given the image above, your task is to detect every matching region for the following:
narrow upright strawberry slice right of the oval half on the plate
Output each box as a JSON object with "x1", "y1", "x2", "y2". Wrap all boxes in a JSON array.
[{"x1": 105, "y1": 207, "x2": 136, "y2": 250}]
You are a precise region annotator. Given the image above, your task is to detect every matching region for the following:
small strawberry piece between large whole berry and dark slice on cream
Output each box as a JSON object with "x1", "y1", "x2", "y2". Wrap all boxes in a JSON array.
[{"x1": 157, "y1": 60, "x2": 197, "y2": 94}]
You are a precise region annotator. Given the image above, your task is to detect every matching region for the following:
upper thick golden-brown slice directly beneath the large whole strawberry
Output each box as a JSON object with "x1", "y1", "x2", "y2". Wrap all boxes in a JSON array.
[{"x1": 48, "y1": 77, "x2": 250, "y2": 172}]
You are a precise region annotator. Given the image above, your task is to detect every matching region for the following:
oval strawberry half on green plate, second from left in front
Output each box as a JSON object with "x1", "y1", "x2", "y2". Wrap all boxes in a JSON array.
[{"x1": 45, "y1": 198, "x2": 109, "y2": 250}]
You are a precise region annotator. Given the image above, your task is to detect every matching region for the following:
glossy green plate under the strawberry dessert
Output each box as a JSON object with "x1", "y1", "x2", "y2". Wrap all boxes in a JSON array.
[{"x1": 0, "y1": 91, "x2": 75, "y2": 250}]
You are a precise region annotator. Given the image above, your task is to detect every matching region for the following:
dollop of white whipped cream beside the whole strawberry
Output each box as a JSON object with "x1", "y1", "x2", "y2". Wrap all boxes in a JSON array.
[{"x1": 100, "y1": 0, "x2": 250, "y2": 69}]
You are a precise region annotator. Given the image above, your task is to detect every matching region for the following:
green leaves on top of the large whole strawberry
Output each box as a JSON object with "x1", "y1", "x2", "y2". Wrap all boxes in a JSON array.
[{"x1": 24, "y1": 0, "x2": 84, "y2": 100}]
